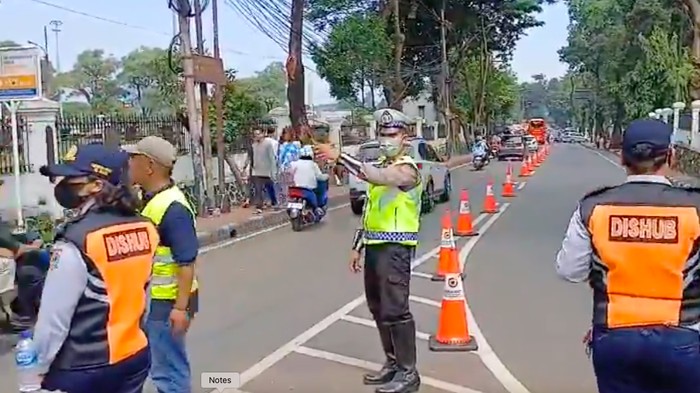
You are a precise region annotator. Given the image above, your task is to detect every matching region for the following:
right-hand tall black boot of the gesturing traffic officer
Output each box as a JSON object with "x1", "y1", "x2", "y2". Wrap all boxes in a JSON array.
[{"x1": 375, "y1": 319, "x2": 420, "y2": 393}]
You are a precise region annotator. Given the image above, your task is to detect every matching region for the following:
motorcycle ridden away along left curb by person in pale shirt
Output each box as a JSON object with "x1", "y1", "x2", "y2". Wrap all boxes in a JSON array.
[{"x1": 287, "y1": 181, "x2": 328, "y2": 232}]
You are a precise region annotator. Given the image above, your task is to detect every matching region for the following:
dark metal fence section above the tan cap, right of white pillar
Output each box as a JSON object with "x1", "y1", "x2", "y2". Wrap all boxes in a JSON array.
[{"x1": 56, "y1": 115, "x2": 190, "y2": 157}]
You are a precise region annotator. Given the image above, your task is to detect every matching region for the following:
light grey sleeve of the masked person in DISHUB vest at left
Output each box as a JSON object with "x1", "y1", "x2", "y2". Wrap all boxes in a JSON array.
[{"x1": 34, "y1": 242, "x2": 88, "y2": 373}]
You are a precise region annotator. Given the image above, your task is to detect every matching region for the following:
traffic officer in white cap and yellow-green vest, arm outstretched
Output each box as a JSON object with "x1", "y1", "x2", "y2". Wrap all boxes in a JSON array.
[{"x1": 316, "y1": 109, "x2": 422, "y2": 393}]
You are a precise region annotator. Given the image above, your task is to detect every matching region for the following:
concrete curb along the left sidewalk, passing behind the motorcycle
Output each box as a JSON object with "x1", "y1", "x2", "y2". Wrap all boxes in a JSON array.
[{"x1": 197, "y1": 155, "x2": 469, "y2": 247}]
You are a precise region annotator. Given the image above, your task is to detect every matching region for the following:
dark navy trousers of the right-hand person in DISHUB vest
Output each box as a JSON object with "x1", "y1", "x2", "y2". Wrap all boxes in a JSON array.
[{"x1": 592, "y1": 326, "x2": 700, "y2": 393}]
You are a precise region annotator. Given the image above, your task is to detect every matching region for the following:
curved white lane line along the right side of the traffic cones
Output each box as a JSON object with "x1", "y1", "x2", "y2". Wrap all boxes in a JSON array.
[{"x1": 459, "y1": 204, "x2": 530, "y2": 393}]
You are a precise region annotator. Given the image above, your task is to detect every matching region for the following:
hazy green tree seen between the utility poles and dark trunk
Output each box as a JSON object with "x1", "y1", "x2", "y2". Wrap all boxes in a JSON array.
[{"x1": 236, "y1": 61, "x2": 287, "y2": 112}]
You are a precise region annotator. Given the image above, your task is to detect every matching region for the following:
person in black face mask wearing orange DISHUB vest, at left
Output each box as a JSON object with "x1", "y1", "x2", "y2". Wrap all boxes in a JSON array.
[{"x1": 34, "y1": 144, "x2": 159, "y2": 393}]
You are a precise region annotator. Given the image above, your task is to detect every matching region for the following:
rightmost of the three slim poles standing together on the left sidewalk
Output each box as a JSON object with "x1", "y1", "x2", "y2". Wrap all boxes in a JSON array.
[{"x1": 211, "y1": 0, "x2": 230, "y2": 213}]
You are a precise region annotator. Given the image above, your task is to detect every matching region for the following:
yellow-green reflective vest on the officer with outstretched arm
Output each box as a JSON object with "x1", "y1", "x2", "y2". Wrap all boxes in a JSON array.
[{"x1": 362, "y1": 156, "x2": 422, "y2": 246}]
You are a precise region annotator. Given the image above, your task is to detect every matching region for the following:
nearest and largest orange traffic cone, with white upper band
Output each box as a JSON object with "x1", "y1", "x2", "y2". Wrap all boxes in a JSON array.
[{"x1": 428, "y1": 273, "x2": 479, "y2": 352}]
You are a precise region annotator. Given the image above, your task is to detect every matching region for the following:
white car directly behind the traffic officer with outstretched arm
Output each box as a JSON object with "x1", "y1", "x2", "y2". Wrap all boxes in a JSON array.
[{"x1": 348, "y1": 138, "x2": 452, "y2": 215}]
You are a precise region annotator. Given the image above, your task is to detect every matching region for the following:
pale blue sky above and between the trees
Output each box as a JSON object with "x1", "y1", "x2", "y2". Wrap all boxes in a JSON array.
[{"x1": 0, "y1": 0, "x2": 568, "y2": 105}]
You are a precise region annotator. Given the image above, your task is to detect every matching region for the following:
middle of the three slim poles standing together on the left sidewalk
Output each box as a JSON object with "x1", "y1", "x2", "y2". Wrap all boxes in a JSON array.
[{"x1": 194, "y1": 0, "x2": 215, "y2": 209}]
